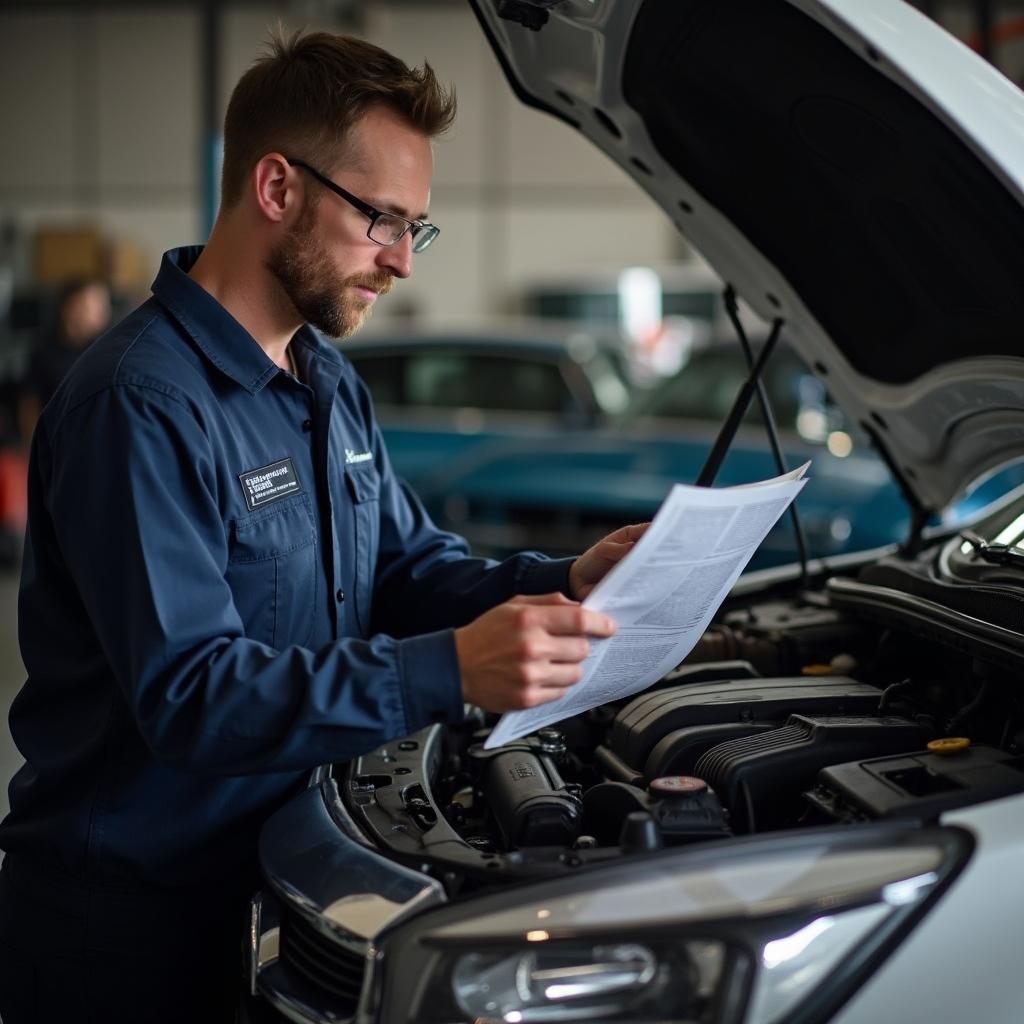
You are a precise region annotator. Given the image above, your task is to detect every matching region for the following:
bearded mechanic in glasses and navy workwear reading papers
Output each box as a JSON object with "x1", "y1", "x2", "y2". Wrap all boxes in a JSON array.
[{"x1": 0, "y1": 28, "x2": 643, "y2": 1024}]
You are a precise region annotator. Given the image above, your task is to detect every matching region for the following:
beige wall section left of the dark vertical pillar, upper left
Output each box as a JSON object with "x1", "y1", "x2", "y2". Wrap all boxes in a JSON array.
[{"x1": 0, "y1": 10, "x2": 199, "y2": 276}]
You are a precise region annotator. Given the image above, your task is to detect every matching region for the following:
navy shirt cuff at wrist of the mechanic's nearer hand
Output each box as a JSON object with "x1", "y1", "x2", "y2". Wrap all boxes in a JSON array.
[{"x1": 398, "y1": 630, "x2": 463, "y2": 735}]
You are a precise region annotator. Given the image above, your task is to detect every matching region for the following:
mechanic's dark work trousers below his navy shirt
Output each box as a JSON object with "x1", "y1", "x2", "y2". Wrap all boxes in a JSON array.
[{"x1": 0, "y1": 858, "x2": 252, "y2": 1024}]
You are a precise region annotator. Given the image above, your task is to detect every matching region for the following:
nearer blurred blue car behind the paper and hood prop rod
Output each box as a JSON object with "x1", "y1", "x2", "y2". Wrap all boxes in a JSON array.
[{"x1": 397, "y1": 345, "x2": 909, "y2": 567}]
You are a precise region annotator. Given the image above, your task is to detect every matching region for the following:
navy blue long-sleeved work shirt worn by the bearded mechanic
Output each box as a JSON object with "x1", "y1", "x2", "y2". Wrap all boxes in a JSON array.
[{"x1": 0, "y1": 248, "x2": 568, "y2": 886}]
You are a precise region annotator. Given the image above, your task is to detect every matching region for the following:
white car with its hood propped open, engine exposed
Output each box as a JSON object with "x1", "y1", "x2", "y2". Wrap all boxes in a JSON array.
[{"x1": 251, "y1": 0, "x2": 1024, "y2": 1024}]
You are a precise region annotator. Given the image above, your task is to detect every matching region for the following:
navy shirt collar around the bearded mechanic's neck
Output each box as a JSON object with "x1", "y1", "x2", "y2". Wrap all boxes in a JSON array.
[{"x1": 153, "y1": 246, "x2": 342, "y2": 394}]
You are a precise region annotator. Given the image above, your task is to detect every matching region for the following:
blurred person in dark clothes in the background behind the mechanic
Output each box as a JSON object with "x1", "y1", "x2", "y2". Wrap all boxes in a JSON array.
[{"x1": 17, "y1": 278, "x2": 111, "y2": 446}]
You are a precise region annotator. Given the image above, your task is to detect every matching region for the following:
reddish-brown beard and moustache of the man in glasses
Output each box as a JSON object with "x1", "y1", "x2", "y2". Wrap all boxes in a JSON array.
[{"x1": 266, "y1": 203, "x2": 394, "y2": 339}]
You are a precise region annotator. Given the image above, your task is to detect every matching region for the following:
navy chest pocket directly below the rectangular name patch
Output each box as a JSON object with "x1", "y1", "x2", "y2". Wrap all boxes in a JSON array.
[{"x1": 227, "y1": 495, "x2": 317, "y2": 648}]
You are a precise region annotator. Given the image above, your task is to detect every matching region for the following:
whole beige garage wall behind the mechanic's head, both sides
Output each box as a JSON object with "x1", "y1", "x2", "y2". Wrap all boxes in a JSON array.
[{"x1": 0, "y1": 3, "x2": 684, "y2": 319}]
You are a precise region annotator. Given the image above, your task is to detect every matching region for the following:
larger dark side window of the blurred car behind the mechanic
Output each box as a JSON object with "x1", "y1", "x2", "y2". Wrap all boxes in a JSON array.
[{"x1": 404, "y1": 352, "x2": 573, "y2": 414}]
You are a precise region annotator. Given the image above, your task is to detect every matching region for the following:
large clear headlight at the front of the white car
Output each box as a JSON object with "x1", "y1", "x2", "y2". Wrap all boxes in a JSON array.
[{"x1": 378, "y1": 826, "x2": 970, "y2": 1024}]
